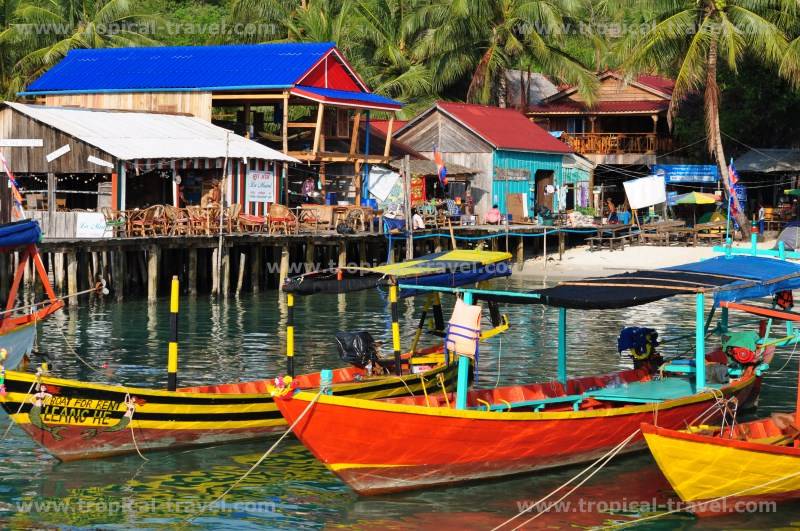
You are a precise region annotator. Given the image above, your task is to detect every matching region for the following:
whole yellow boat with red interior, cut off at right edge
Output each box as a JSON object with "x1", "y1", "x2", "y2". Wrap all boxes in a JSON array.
[{"x1": 642, "y1": 302, "x2": 800, "y2": 516}]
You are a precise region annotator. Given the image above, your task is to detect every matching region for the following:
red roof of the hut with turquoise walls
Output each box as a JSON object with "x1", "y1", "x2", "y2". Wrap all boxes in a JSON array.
[{"x1": 436, "y1": 101, "x2": 572, "y2": 153}]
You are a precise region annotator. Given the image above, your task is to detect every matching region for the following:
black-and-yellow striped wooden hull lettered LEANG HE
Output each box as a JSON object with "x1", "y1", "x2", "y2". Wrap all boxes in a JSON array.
[{"x1": 0, "y1": 364, "x2": 457, "y2": 461}]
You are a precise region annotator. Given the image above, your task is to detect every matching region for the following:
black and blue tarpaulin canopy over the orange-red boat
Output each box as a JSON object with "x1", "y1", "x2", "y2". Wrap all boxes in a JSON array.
[{"x1": 478, "y1": 255, "x2": 800, "y2": 310}]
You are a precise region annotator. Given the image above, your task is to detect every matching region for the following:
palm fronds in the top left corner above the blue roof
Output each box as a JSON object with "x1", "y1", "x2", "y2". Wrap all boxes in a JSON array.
[{"x1": 5, "y1": 0, "x2": 158, "y2": 91}]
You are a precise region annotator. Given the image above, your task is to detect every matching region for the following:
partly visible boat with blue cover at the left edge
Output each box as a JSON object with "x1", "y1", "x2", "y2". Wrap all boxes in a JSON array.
[{"x1": 0, "y1": 220, "x2": 64, "y2": 370}]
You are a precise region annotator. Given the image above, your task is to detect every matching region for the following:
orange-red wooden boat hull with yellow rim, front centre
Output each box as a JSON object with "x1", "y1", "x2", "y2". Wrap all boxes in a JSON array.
[{"x1": 276, "y1": 373, "x2": 756, "y2": 495}]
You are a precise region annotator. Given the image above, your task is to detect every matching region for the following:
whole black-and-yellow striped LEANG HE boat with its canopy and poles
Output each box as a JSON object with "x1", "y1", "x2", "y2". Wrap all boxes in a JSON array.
[{"x1": 0, "y1": 251, "x2": 511, "y2": 461}]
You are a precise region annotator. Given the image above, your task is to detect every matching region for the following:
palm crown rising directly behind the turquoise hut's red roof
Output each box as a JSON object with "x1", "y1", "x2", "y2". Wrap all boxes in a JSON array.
[{"x1": 416, "y1": 0, "x2": 596, "y2": 106}]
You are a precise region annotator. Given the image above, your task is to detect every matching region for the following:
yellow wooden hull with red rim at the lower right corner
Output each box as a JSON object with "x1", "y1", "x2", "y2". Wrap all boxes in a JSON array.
[{"x1": 642, "y1": 419, "x2": 800, "y2": 515}]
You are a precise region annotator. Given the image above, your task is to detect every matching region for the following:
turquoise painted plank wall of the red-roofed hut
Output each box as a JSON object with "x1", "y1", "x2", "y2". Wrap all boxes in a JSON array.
[{"x1": 492, "y1": 150, "x2": 564, "y2": 213}]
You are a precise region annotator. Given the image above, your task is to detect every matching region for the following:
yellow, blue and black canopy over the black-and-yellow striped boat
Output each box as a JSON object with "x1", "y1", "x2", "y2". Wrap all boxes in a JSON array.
[{"x1": 283, "y1": 250, "x2": 511, "y2": 297}]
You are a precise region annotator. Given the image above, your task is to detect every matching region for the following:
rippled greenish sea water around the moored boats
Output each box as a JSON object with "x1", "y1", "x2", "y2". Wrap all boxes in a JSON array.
[{"x1": 0, "y1": 280, "x2": 800, "y2": 530}]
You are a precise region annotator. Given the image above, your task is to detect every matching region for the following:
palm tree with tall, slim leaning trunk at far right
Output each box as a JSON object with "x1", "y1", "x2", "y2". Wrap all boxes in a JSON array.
[{"x1": 624, "y1": 0, "x2": 797, "y2": 227}]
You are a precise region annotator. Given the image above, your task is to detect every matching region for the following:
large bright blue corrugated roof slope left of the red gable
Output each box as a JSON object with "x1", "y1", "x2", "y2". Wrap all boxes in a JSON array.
[{"x1": 26, "y1": 42, "x2": 335, "y2": 94}]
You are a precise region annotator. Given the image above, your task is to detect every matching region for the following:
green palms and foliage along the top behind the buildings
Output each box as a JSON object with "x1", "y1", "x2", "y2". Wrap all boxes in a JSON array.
[{"x1": 0, "y1": 0, "x2": 800, "y2": 157}]
